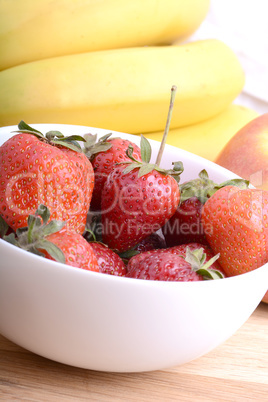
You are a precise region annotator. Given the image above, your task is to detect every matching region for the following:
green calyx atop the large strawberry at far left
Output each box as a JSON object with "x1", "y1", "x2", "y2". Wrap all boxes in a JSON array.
[{"x1": 14, "y1": 120, "x2": 85, "y2": 152}]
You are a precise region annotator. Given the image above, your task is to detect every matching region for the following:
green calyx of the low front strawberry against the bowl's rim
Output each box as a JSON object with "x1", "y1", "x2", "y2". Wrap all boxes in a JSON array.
[{"x1": 181, "y1": 247, "x2": 224, "y2": 279}]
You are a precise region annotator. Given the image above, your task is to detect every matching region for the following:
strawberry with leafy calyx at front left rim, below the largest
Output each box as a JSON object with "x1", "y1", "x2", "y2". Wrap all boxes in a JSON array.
[{"x1": 4, "y1": 205, "x2": 99, "y2": 272}]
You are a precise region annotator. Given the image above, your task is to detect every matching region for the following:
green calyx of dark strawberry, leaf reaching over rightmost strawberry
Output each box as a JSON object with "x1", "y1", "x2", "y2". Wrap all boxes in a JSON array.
[{"x1": 180, "y1": 169, "x2": 249, "y2": 204}]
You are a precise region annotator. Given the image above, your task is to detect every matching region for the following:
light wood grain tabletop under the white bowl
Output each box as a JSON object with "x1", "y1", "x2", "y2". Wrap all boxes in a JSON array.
[{"x1": 0, "y1": 303, "x2": 268, "y2": 402}]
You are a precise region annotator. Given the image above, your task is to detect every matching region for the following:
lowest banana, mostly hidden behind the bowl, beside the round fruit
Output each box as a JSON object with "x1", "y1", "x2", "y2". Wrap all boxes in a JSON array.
[{"x1": 145, "y1": 104, "x2": 258, "y2": 161}]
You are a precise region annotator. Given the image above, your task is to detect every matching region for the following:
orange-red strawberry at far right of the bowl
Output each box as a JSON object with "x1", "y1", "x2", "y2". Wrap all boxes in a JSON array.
[{"x1": 202, "y1": 186, "x2": 268, "y2": 276}]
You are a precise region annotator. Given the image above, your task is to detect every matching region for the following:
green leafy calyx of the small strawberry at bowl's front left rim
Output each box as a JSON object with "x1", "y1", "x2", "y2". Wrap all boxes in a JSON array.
[{"x1": 3, "y1": 204, "x2": 66, "y2": 263}]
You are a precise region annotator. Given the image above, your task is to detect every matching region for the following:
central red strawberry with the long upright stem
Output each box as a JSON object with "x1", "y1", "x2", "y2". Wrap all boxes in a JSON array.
[{"x1": 101, "y1": 136, "x2": 182, "y2": 252}]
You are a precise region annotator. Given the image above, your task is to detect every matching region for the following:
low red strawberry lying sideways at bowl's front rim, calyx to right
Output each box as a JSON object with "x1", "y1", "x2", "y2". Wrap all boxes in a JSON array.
[{"x1": 126, "y1": 245, "x2": 223, "y2": 282}]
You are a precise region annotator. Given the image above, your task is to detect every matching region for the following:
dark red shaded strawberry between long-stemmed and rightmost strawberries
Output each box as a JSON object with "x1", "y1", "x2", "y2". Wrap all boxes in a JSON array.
[{"x1": 162, "y1": 169, "x2": 249, "y2": 247}]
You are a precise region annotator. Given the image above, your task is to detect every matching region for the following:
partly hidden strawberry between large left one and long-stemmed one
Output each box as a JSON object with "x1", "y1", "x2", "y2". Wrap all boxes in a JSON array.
[{"x1": 84, "y1": 134, "x2": 141, "y2": 211}]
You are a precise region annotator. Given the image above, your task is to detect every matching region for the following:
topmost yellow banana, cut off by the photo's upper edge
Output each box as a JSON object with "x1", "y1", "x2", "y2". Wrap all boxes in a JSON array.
[{"x1": 0, "y1": 0, "x2": 210, "y2": 70}]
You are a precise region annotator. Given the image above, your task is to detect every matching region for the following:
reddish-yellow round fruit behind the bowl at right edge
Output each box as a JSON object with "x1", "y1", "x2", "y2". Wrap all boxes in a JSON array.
[{"x1": 215, "y1": 113, "x2": 268, "y2": 303}]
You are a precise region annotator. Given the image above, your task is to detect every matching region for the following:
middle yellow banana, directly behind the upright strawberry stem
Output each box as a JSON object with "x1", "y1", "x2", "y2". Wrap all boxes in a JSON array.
[{"x1": 0, "y1": 40, "x2": 244, "y2": 133}]
